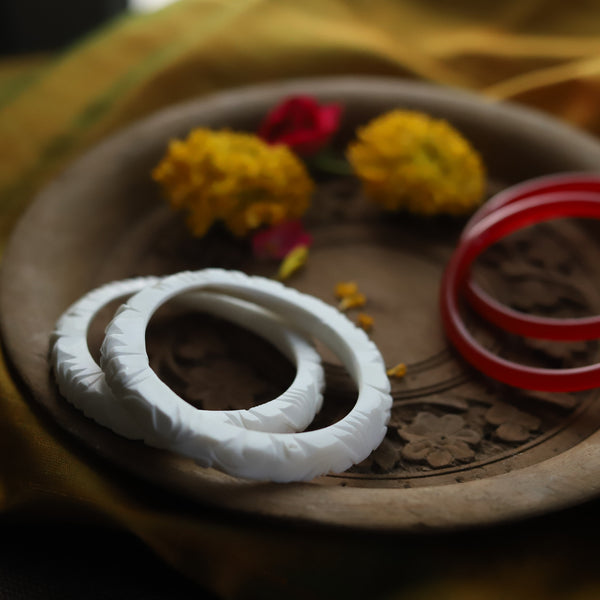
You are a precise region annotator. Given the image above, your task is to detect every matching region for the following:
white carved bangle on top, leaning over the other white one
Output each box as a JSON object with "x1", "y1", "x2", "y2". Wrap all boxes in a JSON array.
[{"x1": 101, "y1": 269, "x2": 392, "y2": 481}]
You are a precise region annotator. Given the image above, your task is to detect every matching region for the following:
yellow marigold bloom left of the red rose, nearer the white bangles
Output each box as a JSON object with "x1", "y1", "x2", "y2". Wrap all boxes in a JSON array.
[{"x1": 152, "y1": 128, "x2": 314, "y2": 236}]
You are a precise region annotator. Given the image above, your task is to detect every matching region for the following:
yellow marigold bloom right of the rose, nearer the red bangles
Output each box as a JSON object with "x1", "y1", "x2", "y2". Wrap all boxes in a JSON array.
[{"x1": 347, "y1": 110, "x2": 485, "y2": 216}]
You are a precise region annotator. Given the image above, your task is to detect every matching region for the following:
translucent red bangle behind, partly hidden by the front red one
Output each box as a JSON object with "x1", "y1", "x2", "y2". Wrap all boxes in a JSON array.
[{"x1": 461, "y1": 173, "x2": 600, "y2": 340}]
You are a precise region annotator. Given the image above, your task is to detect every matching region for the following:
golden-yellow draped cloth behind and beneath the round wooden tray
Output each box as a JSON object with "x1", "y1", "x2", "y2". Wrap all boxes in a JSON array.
[{"x1": 0, "y1": 0, "x2": 600, "y2": 599}]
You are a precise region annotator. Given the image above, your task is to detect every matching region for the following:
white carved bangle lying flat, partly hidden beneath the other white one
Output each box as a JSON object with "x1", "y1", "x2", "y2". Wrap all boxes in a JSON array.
[{"x1": 50, "y1": 277, "x2": 324, "y2": 439}]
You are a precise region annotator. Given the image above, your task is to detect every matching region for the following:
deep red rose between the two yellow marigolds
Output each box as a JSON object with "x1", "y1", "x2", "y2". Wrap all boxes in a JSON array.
[{"x1": 258, "y1": 96, "x2": 342, "y2": 156}]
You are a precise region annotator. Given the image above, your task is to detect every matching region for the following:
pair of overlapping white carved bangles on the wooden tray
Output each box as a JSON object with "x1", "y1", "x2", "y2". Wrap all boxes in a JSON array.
[{"x1": 51, "y1": 269, "x2": 392, "y2": 482}]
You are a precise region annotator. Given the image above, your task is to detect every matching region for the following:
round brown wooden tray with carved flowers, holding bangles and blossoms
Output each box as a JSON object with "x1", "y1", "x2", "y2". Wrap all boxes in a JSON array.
[{"x1": 0, "y1": 78, "x2": 600, "y2": 530}]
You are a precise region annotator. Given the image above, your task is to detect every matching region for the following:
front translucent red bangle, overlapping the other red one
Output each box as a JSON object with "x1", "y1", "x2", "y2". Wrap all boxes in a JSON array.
[{"x1": 440, "y1": 193, "x2": 600, "y2": 392}]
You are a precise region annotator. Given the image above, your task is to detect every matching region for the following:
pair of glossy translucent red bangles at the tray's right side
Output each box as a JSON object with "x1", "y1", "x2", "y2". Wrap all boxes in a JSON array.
[{"x1": 440, "y1": 174, "x2": 600, "y2": 392}]
